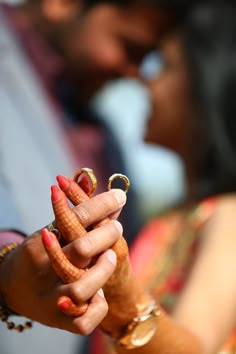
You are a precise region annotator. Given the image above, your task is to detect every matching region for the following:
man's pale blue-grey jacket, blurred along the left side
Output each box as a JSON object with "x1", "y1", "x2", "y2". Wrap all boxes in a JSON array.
[{"x1": 0, "y1": 12, "x2": 84, "y2": 354}]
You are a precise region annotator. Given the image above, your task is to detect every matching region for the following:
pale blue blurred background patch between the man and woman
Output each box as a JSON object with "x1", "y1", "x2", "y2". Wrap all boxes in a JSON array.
[{"x1": 93, "y1": 77, "x2": 184, "y2": 220}]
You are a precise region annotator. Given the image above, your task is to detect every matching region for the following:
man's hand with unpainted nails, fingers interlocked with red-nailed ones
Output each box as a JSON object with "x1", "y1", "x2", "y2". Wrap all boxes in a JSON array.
[{"x1": 0, "y1": 190, "x2": 125, "y2": 335}]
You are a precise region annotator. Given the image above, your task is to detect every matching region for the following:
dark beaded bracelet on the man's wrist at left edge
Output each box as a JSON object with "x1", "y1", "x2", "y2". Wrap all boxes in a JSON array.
[{"x1": 0, "y1": 242, "x2": 33, "y2": 332}]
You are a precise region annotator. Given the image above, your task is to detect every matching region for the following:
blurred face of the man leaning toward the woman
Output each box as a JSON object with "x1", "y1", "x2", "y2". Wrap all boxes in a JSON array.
[{"x1": 46, "y1": 4, "x2": 170, "y2": 98}]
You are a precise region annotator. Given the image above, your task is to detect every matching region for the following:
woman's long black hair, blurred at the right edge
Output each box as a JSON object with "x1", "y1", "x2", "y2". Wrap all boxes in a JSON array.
[{"x1": 183, "y1": 0, "x2": 236, "y2": 196}]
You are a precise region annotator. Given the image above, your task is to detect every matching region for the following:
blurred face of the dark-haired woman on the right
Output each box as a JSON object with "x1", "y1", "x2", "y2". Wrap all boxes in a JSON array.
[{"x1": 145, "y1": 32, "x2": 192, "y2": 156}]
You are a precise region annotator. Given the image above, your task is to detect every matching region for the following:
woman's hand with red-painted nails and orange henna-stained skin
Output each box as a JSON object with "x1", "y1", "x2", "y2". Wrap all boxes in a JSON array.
[{"x1": 44, "y1": 176, "x2": 150, "y2": 338}]
